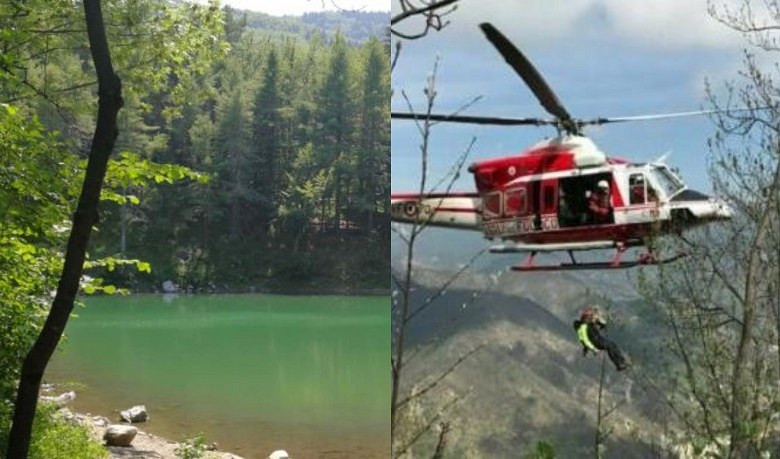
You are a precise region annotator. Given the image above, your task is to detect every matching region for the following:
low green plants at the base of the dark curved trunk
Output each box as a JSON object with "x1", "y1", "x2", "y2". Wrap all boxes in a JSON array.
[{"x1": 0, "y1": 402, "x2": 108, "y2": 459}]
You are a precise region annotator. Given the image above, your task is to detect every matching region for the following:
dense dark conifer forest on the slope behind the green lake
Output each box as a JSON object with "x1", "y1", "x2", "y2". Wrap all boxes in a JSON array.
[{"x1": 5, "y1": 8, "x2": 390, "y2": 291}]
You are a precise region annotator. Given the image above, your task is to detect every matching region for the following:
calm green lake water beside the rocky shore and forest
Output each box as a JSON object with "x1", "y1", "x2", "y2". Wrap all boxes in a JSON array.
[{"x1": 46, "y1": 295, "x2": 390, "y2": 458}]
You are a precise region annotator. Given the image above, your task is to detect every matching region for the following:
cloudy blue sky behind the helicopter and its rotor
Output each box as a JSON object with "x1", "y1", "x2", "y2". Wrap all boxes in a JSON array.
[{"x1": 392, "y1": 0, "x2": 746, "y2": 192}]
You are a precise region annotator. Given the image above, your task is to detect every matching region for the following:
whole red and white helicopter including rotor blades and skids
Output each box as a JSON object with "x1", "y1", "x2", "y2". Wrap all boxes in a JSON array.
[{"x1": 391, "y1": 23, "x2": 732, "y2": 271}]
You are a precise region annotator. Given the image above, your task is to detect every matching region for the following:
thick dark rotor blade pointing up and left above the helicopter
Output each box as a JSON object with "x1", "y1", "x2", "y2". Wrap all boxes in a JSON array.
[{"x1": 479, "y1": 22, "x2": 573, "y2": 126}]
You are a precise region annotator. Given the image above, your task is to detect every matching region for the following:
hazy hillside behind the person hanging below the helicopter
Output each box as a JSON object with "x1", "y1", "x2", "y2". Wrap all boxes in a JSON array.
[{"x1": 394, "y1": 269, "x2": 663, "y2": 457}]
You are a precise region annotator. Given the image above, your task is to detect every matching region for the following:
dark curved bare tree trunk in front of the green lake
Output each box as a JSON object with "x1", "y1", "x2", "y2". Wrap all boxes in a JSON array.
[{"x1": 7, "y1": 0, "x2": 122, "y2": 459}]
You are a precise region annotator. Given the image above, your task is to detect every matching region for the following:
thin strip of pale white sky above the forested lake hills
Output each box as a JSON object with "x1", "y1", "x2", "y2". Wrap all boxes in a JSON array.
[{"x1": 223, "y1": 0, "x2": 390, "y2": 16}]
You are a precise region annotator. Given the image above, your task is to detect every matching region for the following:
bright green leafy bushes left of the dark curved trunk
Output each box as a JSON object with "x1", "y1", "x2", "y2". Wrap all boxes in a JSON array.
[{"x1": 0, "y1": 106, "x2": 79, "y2": 399}]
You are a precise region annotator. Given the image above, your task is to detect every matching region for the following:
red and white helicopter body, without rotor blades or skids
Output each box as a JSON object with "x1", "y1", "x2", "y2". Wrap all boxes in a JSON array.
[{"x1": 392, "y1": 136, "x2": 731, "y2": 251}]
